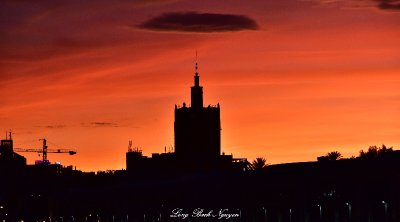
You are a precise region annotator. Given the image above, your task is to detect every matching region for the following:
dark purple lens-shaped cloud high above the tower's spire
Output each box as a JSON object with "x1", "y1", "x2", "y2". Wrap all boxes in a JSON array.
[{"x1": 137, "y1": 12, "x2": 258, "y2": 32}]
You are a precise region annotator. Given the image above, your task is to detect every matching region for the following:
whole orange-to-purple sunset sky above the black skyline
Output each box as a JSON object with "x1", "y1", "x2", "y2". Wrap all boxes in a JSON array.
[{"x1": 0, "y1": 0, "x2": 400, "y2": 171}]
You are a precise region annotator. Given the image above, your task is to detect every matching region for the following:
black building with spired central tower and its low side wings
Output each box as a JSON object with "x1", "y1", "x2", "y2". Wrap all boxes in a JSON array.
[{"x1": 126, "y1": 63, "x2": 247, "y2": 174}]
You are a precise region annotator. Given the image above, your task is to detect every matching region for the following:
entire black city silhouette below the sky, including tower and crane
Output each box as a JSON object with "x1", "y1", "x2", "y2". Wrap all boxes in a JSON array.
[{"x1": 0, "y1": 63, "x2": 400, "y2": 222}]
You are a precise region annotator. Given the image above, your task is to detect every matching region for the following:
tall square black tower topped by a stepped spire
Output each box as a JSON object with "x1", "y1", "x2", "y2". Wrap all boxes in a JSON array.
[{"x1": 174, "y1": 63, "x2": 221, "y2": 160}]
